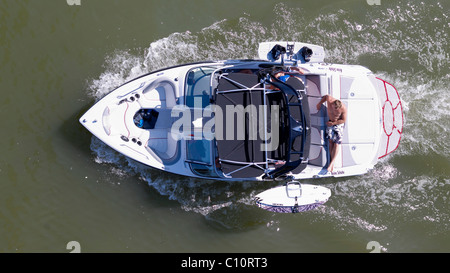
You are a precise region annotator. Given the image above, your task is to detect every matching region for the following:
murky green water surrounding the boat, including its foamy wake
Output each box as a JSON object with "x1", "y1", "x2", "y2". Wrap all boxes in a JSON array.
[{"x1": 0, "y1": 0, "x2": 450, "y2": 253}]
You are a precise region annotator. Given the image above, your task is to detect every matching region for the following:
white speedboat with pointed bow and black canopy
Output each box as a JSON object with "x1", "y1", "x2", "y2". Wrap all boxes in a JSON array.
[{"x1": 80, "y1": 41, "x2": 403, "y2": 212}]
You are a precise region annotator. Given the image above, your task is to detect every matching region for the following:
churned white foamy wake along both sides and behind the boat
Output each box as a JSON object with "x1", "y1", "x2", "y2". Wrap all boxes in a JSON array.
[{"x1": 88, "y1": 2, "x2": 450, "y2": 233}]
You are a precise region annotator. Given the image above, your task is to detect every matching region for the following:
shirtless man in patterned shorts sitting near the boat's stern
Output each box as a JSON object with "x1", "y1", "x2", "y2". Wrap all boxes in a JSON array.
[{"x1": 317, "y1": 95, "x2": 347, "y2": 172}]
